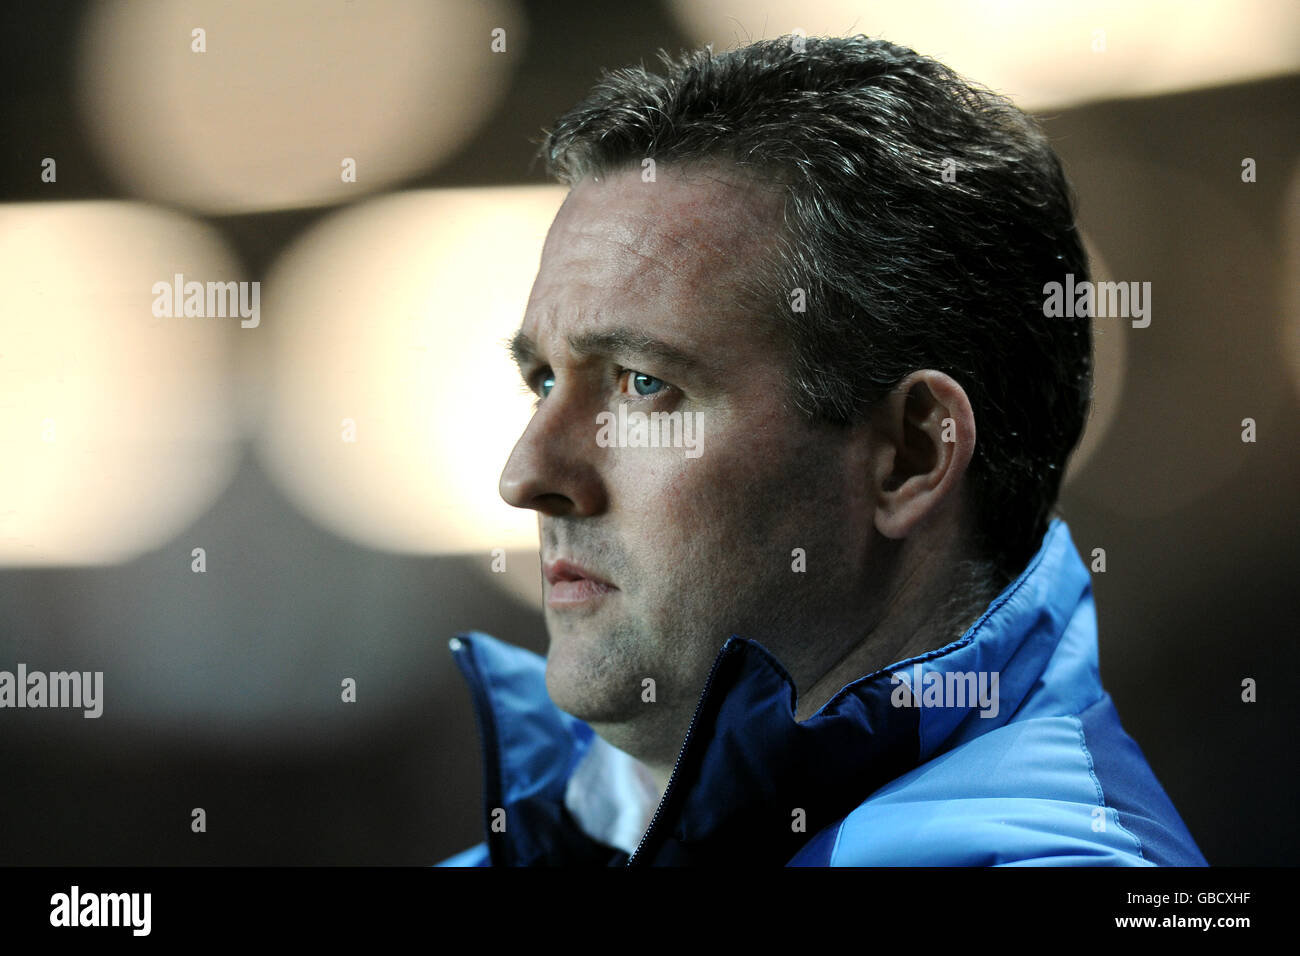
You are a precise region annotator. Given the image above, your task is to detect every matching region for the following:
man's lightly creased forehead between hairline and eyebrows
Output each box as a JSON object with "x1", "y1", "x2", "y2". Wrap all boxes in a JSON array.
[{"x1": 521, "y1": 165, "x2": 784, "y2": 345}]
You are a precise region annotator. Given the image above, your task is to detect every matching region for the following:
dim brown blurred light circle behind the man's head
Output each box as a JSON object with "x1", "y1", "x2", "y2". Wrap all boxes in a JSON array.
[{"x1": 1050, "y1": 153, "x2": 1287, "y2": 519}]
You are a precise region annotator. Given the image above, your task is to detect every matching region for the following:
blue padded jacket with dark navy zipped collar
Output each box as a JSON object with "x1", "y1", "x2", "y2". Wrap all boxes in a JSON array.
[{"x1": 441, "y1": 519, "x2": 1205, "y2": 866}]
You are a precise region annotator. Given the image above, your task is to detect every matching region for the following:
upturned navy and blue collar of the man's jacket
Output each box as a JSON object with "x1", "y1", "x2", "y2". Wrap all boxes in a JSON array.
[{"x1": 452, "y1": 519, "x2": 1101, "y2": 865}]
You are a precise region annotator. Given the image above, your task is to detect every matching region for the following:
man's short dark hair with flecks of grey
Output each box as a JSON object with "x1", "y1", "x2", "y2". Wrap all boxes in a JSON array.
[{"x1": 541, "y1": 35, "x2": 1092, "y2": 582}]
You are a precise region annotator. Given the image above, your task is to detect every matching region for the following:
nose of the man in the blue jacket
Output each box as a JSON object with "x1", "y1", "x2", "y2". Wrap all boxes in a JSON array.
[{"x1": 498, "y1": 392, "x2": 606, "y2": 516}]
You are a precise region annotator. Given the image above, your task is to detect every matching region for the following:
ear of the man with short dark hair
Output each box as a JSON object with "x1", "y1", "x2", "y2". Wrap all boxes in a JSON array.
[{"x1": 871, "y1": 368, "x2": 975, "y2": 538}]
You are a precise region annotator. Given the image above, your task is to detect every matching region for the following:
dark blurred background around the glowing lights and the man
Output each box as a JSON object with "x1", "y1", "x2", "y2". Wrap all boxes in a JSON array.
[{"x1": 0, "y1": 3, "x2": 1300, "y2": 865}]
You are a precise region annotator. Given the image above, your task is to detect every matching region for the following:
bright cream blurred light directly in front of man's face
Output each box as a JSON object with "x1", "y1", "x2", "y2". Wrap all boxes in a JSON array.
[{"x1": 257, "y1": 186, "x2": 567, "y2": 561}]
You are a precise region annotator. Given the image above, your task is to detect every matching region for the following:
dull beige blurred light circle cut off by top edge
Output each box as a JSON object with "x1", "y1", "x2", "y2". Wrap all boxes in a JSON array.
[{"x1": 79, "y1": 0, "x2": 524, "y2": 213}]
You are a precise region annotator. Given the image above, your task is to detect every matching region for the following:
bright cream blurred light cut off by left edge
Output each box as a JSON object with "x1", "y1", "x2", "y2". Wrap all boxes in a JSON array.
[{"x1": 0, "y1": 202, "x2": 245, "y2": 566}]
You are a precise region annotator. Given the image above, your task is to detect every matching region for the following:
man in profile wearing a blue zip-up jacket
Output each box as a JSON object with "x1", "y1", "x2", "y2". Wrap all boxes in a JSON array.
[{"x1": 446, "y1": 36, "x2": 1205, "y2": 865}]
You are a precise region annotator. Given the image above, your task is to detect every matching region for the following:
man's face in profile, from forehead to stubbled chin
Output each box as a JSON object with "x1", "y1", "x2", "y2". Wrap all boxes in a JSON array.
[{"x1": 501, "y1": 165, "x2": 871, "y2": 761}]
